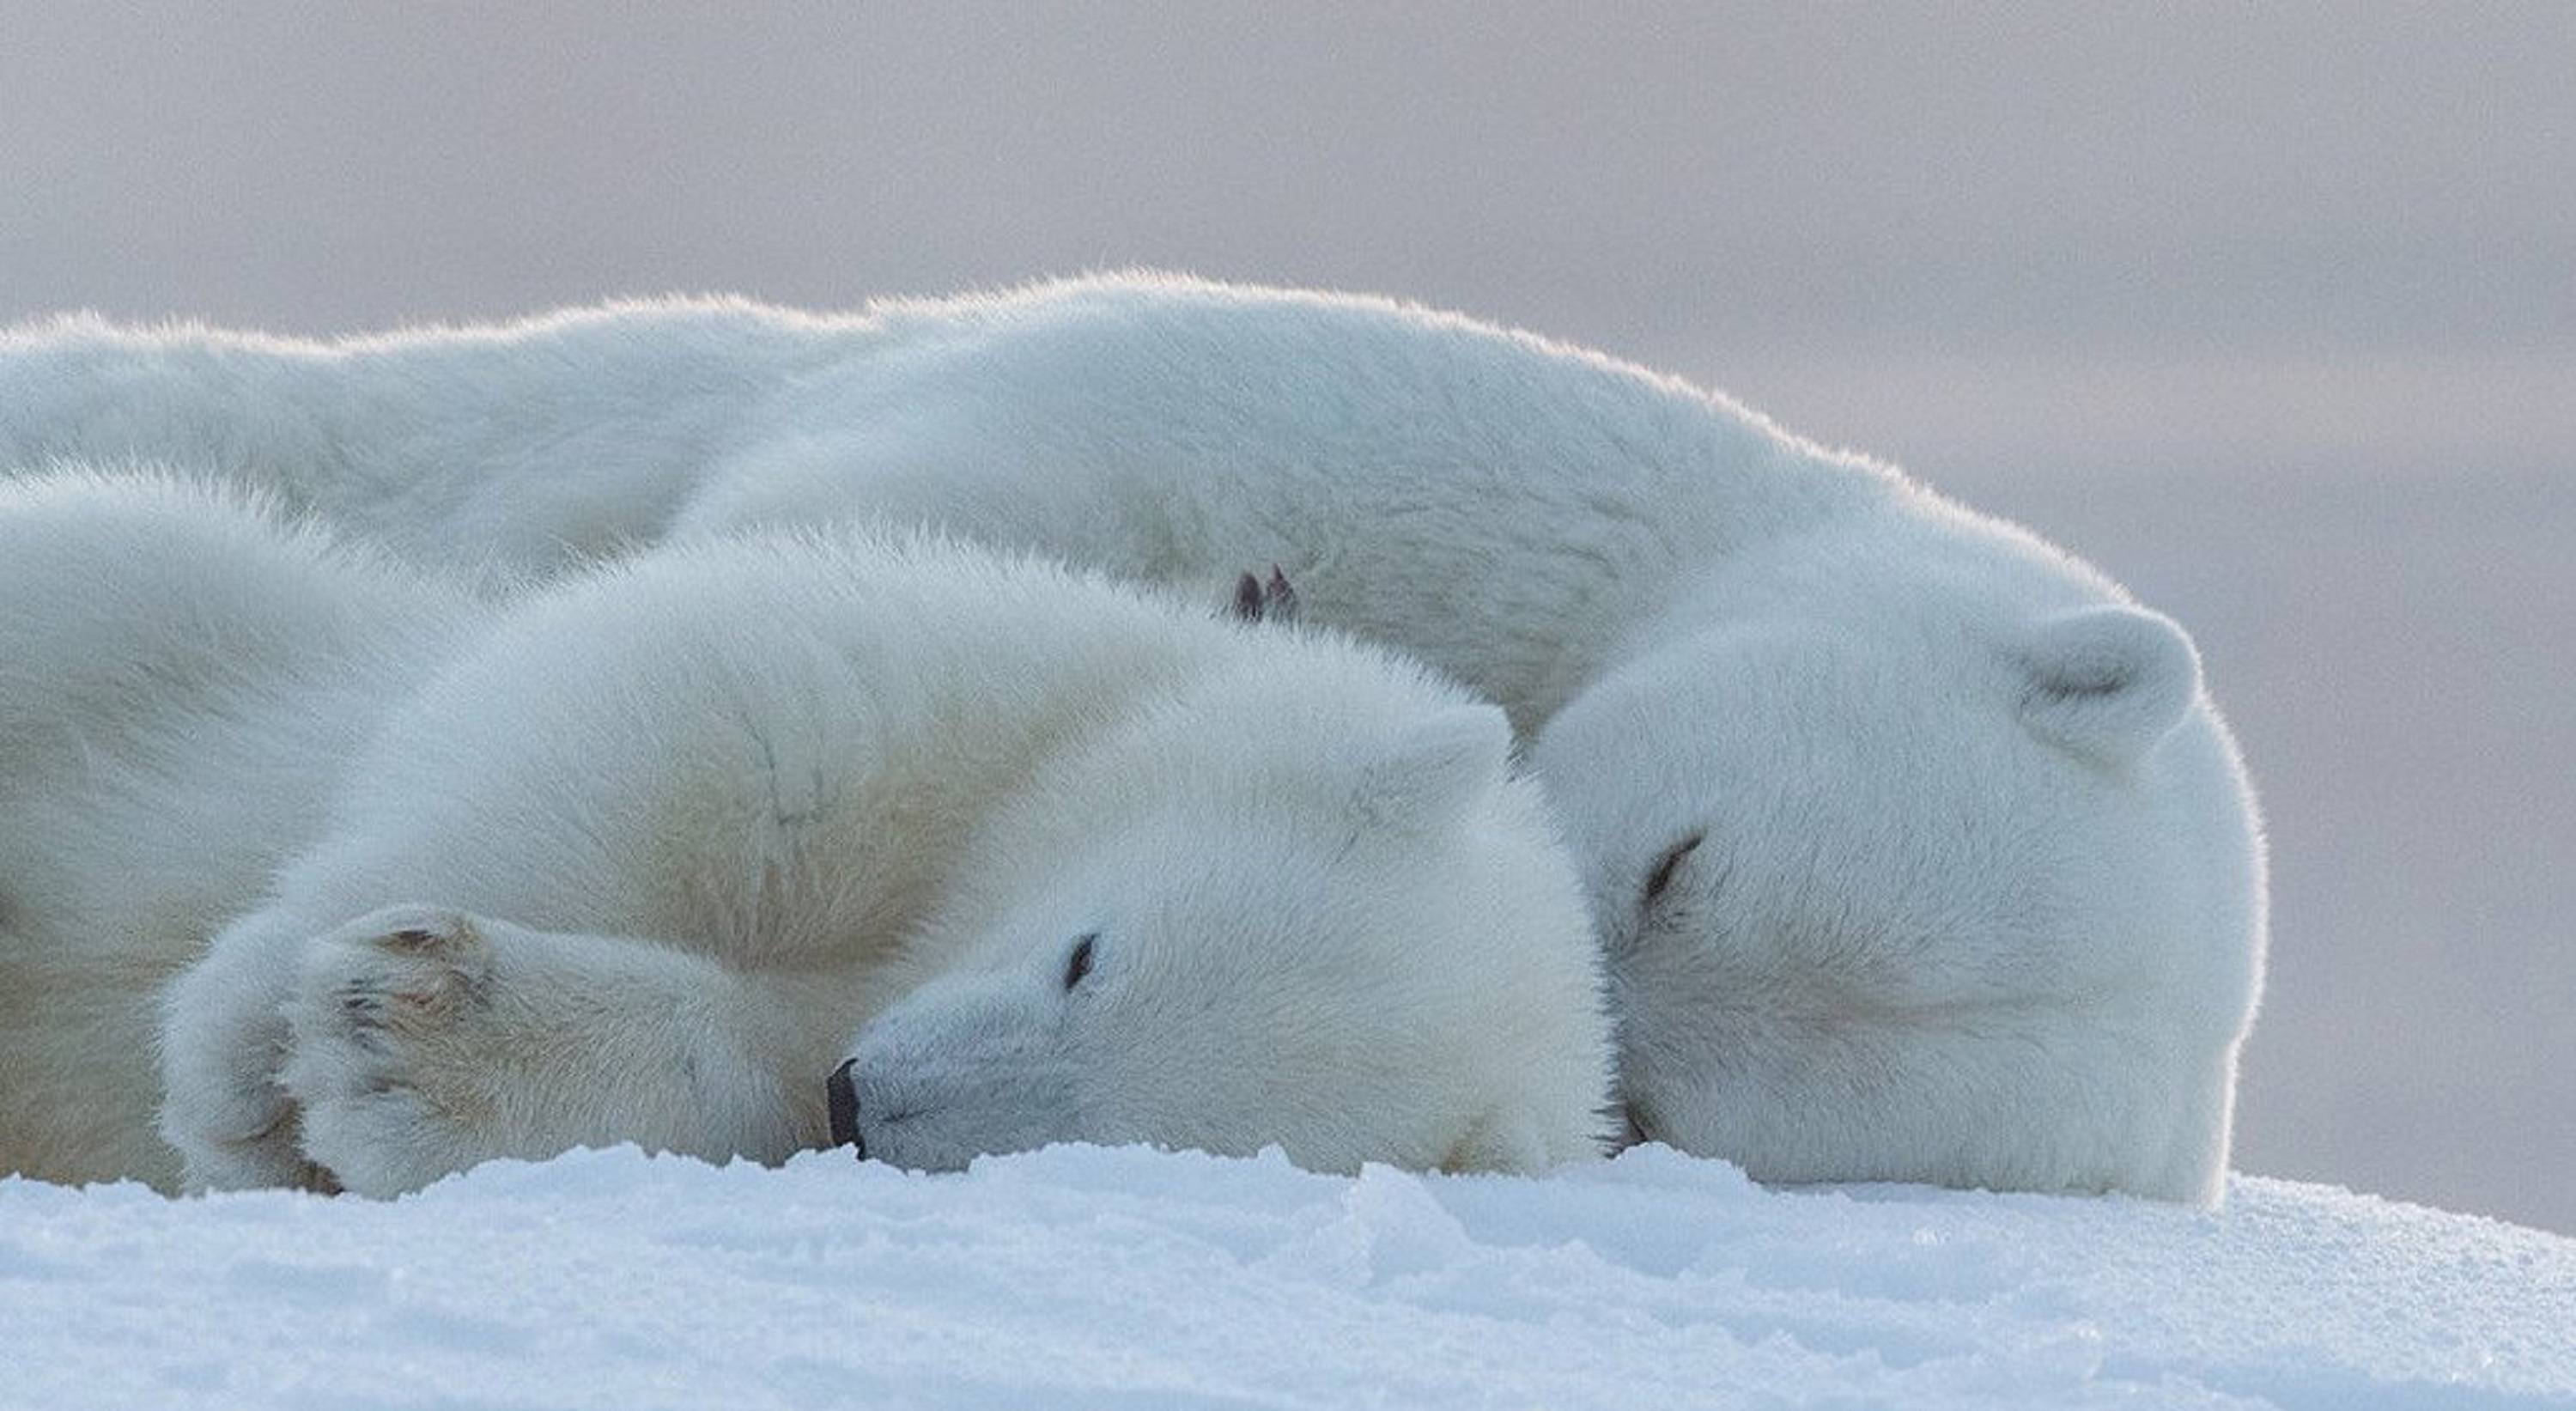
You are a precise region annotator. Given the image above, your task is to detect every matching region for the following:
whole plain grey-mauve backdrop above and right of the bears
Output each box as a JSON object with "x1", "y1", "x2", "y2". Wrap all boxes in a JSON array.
[{"x1": 0, "y1": 0, "x2": 2576, "y2": 1233}]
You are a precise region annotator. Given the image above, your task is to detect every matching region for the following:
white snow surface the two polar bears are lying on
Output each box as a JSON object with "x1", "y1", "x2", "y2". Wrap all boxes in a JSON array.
[{"x1": 0, "y1": 1146, "x2": 2576, "y2": 1411}]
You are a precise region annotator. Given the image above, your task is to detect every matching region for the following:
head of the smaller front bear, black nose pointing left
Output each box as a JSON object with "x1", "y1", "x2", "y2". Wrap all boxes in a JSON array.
[{"x1": 832, "y1": 669, "x2": 1613, "y2": 1171}]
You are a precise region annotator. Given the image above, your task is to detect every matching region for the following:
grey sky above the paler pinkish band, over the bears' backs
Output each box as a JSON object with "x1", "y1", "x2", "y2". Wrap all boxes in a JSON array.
[{"x1": 0, "y1": 0, "x2": 2576, "y2": 386}]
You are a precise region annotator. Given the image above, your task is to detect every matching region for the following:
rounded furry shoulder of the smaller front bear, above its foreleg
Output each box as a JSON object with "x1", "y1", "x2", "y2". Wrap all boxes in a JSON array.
[{"x1": 279, "y1": 536, "x2": 1249, "y2": 963}]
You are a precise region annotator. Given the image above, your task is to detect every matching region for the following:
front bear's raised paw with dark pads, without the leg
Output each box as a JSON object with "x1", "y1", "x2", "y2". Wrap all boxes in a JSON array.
[{"x1": 281, "y1": 906, "x2": 500, "y2": 1195}]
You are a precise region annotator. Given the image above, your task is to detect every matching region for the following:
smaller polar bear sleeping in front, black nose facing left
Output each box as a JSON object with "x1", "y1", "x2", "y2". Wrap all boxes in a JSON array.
[{"x1": 0, "y1": 477, "x2": 1610, "y2": 1195}]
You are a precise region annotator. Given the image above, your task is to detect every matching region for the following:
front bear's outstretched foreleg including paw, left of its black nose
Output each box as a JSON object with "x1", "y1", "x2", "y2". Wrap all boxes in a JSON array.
[{"x1": 281, "y1": 906, "x2": 827, "y2": 1195}]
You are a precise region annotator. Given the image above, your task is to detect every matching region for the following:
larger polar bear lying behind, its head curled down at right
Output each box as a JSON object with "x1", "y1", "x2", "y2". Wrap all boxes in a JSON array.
[{"x1": 0, "y1": 276, "x2": 2264, "y2": 1200}]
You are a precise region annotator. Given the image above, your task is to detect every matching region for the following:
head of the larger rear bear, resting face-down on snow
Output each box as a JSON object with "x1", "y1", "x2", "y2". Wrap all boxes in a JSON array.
[{"x1": 1533, "y1": 508, "x2": 2264, "y2": 1200}]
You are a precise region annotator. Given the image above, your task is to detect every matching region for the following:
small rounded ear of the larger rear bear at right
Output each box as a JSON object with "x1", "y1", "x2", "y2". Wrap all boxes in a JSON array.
[{"x1": 2020, "y1": 608, "x2": 2200, "y2": 764}]
